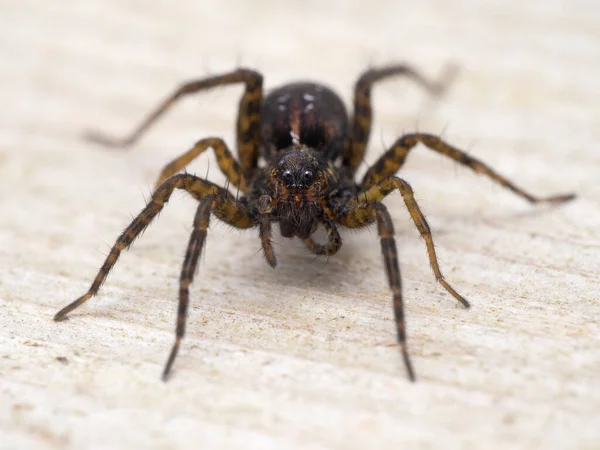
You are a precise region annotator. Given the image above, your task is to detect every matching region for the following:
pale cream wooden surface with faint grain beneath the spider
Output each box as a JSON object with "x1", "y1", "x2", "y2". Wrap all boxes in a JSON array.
[{"x1": 0, "y1": 0, "x2": 600, "y2": 450}]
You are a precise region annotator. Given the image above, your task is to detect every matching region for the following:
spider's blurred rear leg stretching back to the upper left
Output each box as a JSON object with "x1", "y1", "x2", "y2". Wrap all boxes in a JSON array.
[{"x1": 87, "y1": 68, "x2": 263, "y2": 171}]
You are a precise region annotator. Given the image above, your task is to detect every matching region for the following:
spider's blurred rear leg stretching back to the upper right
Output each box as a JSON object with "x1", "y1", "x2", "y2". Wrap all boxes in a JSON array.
[{"x1": 343, "y1": 64, "x2": 456, "y2": 173}]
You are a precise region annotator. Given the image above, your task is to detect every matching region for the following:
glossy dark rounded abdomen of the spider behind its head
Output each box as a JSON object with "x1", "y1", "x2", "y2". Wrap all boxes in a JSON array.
[{"x1": 260, "y1": 83, "x2": 348, "y2": 161}]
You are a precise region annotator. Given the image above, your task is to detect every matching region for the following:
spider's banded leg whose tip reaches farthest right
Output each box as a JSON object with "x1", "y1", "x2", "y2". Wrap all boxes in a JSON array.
[{"x1": 362, "y1": 133, "x2": 575, "y2": 203}]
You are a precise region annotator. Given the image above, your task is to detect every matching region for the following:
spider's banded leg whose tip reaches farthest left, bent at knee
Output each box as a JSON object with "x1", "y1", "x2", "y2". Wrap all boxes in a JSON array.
[{"x1": 54, "y1": 174, "x2": 256, "y2": 321}]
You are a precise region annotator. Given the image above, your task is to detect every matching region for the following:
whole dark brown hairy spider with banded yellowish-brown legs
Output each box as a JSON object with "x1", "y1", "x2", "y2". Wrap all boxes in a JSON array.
[{"x1": 54, "y1": 65, "x2": 574, "y2": 381}]
